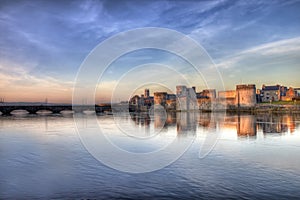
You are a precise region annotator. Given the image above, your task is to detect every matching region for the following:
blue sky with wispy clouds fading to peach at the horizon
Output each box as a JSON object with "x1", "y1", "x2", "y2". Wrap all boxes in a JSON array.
[{"x1": 0, "y1": 0, "x2": 300, "y2": 103}]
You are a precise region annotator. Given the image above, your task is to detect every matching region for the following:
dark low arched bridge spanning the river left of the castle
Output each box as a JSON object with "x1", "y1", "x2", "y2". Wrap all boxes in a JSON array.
[{"x1": 0, "y1": 104, "x2": 111, "y2": 115}]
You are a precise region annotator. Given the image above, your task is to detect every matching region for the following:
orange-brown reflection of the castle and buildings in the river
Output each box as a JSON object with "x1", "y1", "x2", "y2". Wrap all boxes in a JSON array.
[{"x1": 131, "y1": 112, "x2": 300, "y2": 138}]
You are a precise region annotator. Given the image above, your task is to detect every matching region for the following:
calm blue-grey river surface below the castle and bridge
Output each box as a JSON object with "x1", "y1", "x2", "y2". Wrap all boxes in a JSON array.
[{"x1": 0, "y1": 113, "x2": 300, "y2": 199}]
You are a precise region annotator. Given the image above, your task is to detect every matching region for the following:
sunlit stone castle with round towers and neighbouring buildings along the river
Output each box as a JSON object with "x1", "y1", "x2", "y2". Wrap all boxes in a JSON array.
[{"x1": 129, "y1": 84, "x2": 300, "y2": 111}]
